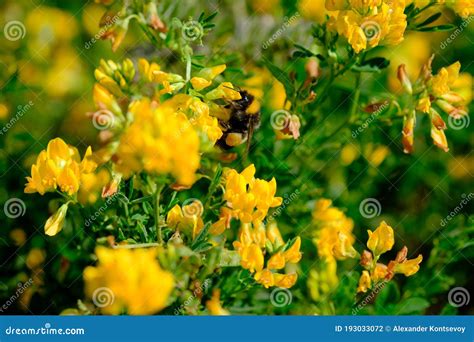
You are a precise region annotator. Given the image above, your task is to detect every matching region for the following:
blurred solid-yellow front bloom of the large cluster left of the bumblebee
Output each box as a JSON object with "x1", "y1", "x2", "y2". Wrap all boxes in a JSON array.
[{"x1": 114, "y1": 99, "x2": 200, "y2": 185}]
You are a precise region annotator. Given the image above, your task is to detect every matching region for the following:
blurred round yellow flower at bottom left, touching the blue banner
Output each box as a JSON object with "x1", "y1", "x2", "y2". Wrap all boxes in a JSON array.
[{"x1": 84, "y1": 247, "x2": 174, "y2": 315}]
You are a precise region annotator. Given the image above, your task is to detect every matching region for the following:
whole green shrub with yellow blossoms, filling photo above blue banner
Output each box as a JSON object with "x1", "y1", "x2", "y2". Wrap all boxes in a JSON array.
[{"x1": 0, "y1": 0, "x2": 474, "y2": 315}]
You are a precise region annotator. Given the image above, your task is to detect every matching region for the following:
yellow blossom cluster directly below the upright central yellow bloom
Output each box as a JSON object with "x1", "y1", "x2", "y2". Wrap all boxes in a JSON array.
[{"x1": 234, "y1": 222, "x2": 301, "y2": 288}]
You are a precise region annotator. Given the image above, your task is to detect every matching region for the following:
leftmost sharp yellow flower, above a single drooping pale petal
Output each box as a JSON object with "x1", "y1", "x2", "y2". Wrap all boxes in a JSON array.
[{"x1": 25, "y1": 138, "x2": 97, "y2": 196}]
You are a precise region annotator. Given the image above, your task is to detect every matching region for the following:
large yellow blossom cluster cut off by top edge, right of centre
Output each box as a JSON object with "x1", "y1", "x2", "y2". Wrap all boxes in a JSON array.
[{"x1": 326, "y1": 0, "x2": 407, "y2": 53}]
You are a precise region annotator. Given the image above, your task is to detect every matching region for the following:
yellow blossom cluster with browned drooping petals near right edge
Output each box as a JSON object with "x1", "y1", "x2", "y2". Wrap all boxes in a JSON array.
[{"x1": 398, "y1": 56, "x2": 472, "y2": 153}]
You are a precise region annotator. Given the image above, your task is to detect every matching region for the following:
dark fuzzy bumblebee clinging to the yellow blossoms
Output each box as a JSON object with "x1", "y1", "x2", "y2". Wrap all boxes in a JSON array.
[{"x1": 217, "y1": 90, "x2": 260, "y2": 151}]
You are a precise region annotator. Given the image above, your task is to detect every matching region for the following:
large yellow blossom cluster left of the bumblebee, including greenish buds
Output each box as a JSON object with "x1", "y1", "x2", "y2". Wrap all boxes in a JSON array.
[{"x1": 93, "y1": 59, "x2": 241, "y2": 186}]
